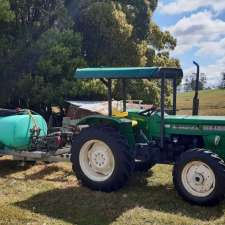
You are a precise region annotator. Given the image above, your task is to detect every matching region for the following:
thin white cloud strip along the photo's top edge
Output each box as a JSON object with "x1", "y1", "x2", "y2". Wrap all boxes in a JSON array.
[{"x1": 159, "y1": 0, "x2": 225, "y2": 15}]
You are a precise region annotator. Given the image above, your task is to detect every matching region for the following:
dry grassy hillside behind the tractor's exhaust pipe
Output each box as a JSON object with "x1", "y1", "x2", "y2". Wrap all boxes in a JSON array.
[{"x1": 177, "y1": 89, "x2": 225, "y2": 116}]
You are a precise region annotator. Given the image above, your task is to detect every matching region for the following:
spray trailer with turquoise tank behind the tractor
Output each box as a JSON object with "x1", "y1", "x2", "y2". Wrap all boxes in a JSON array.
[{"x1": 0, "y1": 109, "x2": 73, "y2": 162}]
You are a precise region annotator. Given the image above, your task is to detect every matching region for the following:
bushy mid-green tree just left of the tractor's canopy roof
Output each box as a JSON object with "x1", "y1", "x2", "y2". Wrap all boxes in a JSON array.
[{"x1": 15, "y1": 29, "x2": 86, "y2": 107}]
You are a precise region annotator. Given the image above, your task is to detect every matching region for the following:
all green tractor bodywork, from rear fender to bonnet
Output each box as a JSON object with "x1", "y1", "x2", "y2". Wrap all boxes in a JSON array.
[{"x1": 78, "y1": 110, "x2": 225, "y2": 159}]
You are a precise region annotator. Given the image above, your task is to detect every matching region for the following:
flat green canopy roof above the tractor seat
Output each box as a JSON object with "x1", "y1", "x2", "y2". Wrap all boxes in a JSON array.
[{"x1": 75, "y1": 67, "x2": 183, "y2": 79}]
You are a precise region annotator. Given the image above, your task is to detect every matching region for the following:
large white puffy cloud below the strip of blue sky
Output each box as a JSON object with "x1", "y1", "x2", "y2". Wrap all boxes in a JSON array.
[{"x1": 164, "y1": 11, "x2": 225, "y2": 56}]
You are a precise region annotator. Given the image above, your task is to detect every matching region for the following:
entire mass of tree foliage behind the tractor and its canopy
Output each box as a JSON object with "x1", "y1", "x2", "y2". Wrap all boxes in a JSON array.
[{"x1": 0, "y1": 0, "x2": 179, "y2": 116}]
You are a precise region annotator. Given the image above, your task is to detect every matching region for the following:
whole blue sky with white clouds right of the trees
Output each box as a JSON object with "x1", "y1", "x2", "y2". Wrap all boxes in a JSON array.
[{"x1": 153, "y1": 0, "x2": 225, "y2": 86}]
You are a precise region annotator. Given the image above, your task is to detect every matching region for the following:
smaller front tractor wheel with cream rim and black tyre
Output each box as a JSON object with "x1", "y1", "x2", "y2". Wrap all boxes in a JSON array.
[{"x1": 173, "y1": 149, "x2": 225, "y2": 206}]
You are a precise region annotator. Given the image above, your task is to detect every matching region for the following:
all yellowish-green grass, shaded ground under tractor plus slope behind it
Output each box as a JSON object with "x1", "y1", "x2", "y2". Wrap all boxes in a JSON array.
[{"x1": 0, "y1": 90, "x2": 225, "y2": 225}]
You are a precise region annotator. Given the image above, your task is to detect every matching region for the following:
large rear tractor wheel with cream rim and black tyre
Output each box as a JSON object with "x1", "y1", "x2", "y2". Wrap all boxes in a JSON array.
[{"x1": 71, "y1": 127, "x2": 133, "y2": 192}]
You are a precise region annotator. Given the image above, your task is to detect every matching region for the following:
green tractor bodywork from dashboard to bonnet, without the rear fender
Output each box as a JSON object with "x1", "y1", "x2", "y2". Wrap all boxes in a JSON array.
[{"x1": 129, "y1": 112, "x2": 225, "y2": 160}]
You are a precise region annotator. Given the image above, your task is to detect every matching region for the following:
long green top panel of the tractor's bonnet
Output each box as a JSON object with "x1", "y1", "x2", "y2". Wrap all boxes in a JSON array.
[{"x1": 165, "y1": 115, "x2": 225, "y2": 128}]
